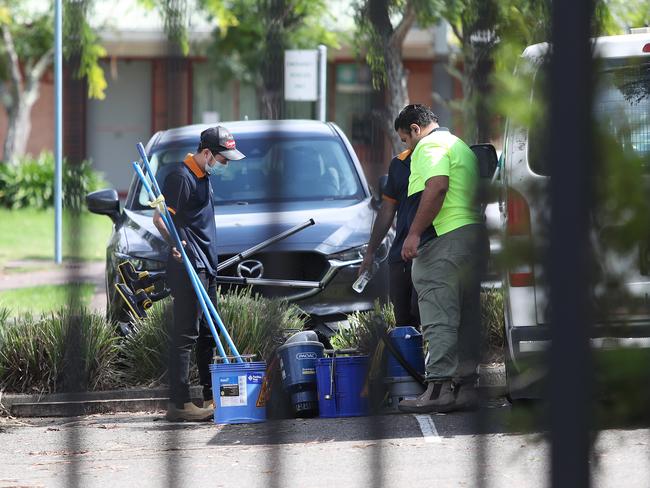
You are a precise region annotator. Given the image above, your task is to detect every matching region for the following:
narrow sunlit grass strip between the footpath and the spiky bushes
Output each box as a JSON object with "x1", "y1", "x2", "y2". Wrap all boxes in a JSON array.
[{"x1": 0, "y1": 284, "x2": 95, "y2": 315}]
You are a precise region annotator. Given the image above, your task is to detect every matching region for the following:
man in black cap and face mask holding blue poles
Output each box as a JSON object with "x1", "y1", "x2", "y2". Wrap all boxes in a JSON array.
[{"x1": 153, "y1": 126, "x2": 245, "y2": 421}]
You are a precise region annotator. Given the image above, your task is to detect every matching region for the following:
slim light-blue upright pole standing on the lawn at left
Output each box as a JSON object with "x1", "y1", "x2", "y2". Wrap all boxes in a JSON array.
[{"x1": 54, "y1": 0, "x2": 63, "y2": 264}]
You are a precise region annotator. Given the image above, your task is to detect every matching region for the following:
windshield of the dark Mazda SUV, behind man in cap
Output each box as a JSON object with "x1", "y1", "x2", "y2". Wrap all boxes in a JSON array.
[{"x1": 139, "y1": 135, "x2": 364, "y2": 206}]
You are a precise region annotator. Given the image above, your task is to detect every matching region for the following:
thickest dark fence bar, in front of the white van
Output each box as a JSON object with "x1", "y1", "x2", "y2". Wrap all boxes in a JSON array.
[{"x1": 546, "y1": 0, "x2": 594, "y2": 488}]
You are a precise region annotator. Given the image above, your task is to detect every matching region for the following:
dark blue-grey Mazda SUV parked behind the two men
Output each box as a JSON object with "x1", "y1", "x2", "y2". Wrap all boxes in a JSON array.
[{"x1": 87, "y1": 120, "x2": 393, "y2": 332}]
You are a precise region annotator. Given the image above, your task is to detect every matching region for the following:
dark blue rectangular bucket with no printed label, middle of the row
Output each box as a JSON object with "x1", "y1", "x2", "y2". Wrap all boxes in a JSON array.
[{"x1": 316, "y1": 356, "x2": 369, "y2": 417}]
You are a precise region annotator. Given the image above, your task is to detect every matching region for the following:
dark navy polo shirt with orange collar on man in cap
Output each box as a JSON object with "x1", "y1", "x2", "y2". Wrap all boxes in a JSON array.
[{"x1": 162, "y1": 154, "x2": 217, "y2": 276}]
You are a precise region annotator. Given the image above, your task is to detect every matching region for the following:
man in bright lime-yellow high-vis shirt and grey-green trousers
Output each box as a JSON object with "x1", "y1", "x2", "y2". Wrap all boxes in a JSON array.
[{"x1": 395, "y1": 105, "x2": 487, "y2": 413}]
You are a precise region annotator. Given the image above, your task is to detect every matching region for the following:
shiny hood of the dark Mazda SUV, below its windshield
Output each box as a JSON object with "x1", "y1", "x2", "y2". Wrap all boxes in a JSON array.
[{"x1": 123, "y1": 198, "x2": 374, "y2": 257}]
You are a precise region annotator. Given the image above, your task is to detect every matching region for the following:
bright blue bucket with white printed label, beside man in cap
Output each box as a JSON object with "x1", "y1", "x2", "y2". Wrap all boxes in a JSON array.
[{"x1": 210, "y1": 361, "x2": 266, "y2": 424}]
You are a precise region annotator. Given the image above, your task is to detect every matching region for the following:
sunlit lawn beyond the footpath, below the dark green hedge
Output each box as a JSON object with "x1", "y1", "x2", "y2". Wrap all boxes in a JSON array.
[{"x1": 0, "y1": 209, "x2": 112, "y2": 269}]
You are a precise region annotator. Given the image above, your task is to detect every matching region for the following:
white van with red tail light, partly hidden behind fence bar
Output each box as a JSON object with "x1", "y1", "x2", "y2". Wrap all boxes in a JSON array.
[{"x1": 499, "y1": 32, "x2": 650, "y2": 398}]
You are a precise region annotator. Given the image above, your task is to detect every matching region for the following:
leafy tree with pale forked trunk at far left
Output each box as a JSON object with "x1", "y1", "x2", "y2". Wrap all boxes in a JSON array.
[{"x1": 0, "y1": 0, "x2": 106, "y2": 161}]
